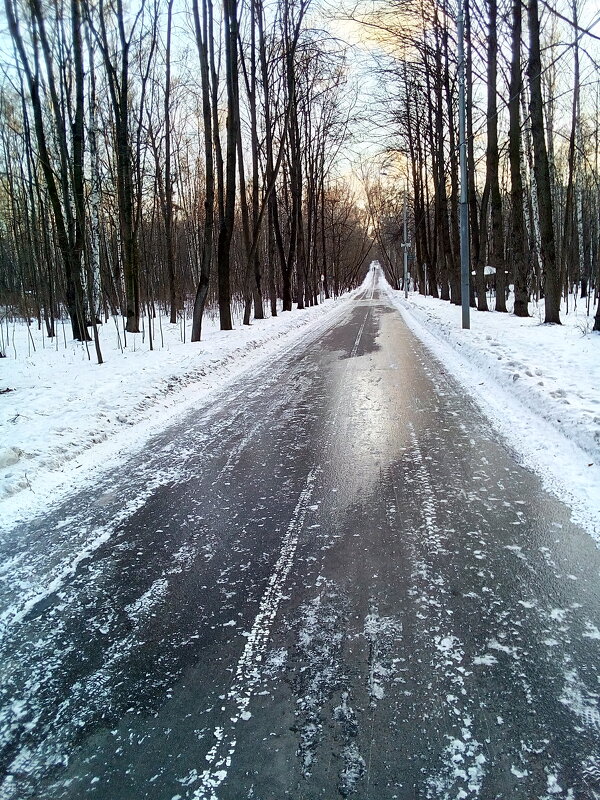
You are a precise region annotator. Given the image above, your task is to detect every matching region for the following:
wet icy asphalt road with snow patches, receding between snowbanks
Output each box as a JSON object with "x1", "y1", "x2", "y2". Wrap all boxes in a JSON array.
[{"x1": 0, "y1": 270, "x2": 600, "y2": 800}]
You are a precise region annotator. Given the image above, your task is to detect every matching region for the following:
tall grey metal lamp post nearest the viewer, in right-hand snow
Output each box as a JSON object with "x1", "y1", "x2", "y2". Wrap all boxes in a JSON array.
[{"x1": 457, "y1": 0, "x2": 471, "y2": 329}]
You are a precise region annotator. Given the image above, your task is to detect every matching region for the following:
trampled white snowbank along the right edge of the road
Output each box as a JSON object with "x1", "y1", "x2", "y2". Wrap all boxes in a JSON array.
[{"x1": 380, "y1": 278, "x2": 600, "y2": 543}]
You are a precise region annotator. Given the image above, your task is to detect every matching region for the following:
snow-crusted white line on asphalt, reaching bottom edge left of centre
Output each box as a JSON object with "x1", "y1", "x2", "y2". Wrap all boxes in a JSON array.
[{"x1": 192, "y1": 467, "x2": 320, "y2": 800}]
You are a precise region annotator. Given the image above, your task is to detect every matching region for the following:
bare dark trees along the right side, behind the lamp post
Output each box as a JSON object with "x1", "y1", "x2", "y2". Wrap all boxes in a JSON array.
[{"x1": 348, "y1": 0, "x2": 600, "y2": 330}]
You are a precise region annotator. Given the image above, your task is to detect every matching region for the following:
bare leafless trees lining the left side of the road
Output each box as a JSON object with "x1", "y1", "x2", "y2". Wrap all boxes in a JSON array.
[{"x1": 0, "y1": 0, "x2": 372, "y2": 360}]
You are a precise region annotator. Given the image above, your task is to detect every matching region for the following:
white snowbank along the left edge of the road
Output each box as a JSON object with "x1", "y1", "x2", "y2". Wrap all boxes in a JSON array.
[{"x1": 0, "y1": 288, "x2": 360, "y2": 528}]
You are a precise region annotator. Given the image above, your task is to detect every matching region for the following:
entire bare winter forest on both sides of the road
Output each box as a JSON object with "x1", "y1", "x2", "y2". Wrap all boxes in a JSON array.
[{"x1": 0, "y1": 0, "x2": 600, "y2": 362}]
